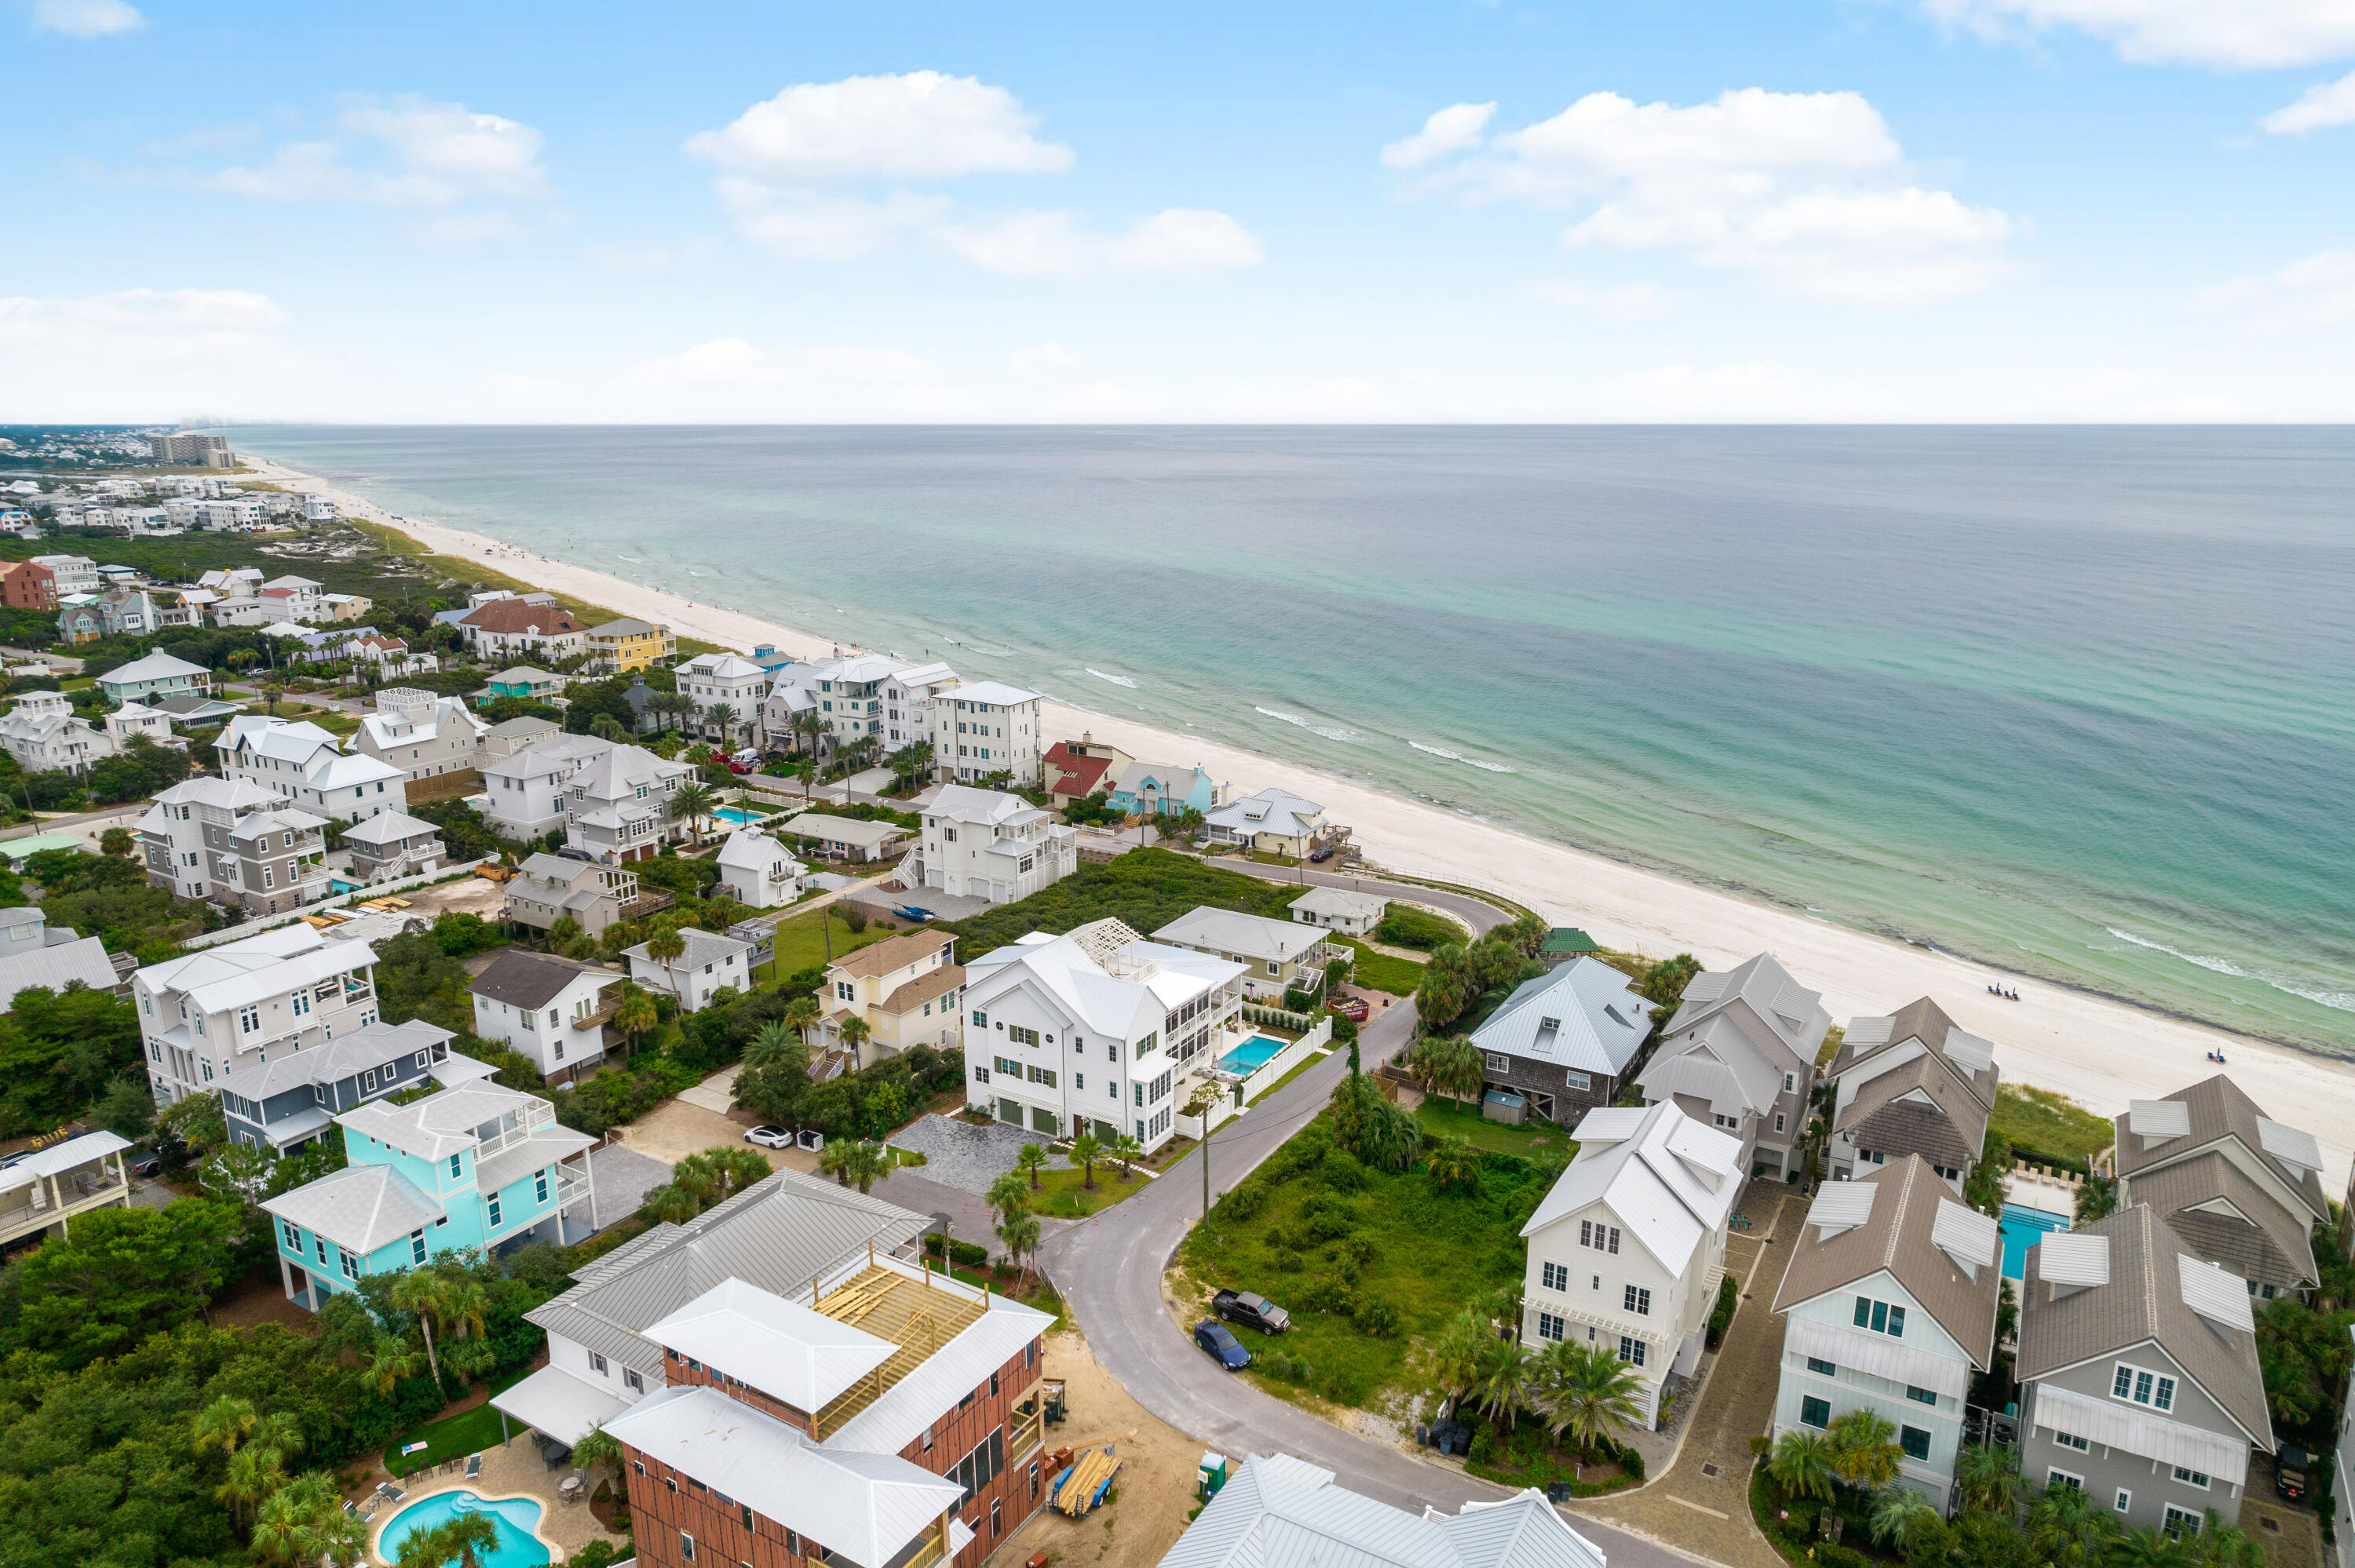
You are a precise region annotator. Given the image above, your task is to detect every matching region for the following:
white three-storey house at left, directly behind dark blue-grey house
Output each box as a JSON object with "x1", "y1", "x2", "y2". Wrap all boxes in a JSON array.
[{"x1": 132, "y1": 923, "x2": 377, "y2": 1104}]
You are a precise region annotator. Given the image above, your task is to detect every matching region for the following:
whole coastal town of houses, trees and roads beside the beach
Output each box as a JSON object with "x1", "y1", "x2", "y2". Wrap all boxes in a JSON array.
[{"x1": 0, "y1": 436, "x2": 2355, "y2": 1568}]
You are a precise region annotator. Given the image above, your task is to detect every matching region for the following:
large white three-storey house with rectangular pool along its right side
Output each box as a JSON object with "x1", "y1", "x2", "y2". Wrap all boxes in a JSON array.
[{"x1": 963, "y1": 918, "x2": 1243, "y2": 1149}]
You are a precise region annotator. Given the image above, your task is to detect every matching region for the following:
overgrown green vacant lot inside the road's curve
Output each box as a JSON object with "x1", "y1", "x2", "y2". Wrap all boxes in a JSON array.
[{"x1": 1178, "y1": 1097, "x2": 1545, "y2": 1406}]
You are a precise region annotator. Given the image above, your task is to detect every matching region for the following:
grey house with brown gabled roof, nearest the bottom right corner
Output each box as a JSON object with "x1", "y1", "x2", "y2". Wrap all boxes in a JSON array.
[{"x1": 2016, "y1": 1203, "x2": 2275, "y2": 1533}]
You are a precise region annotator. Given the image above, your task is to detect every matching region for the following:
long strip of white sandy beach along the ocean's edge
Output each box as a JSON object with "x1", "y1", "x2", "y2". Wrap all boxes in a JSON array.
[{"x1": 247, "y1": 459, "x2": 2355, "y2": 1194}]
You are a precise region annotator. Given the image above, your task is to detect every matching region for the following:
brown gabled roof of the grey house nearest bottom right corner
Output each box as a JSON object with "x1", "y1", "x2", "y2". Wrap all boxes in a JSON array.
[{"x1": 2018, "y1": 1203, "x2": 2273, "y2": 1453}]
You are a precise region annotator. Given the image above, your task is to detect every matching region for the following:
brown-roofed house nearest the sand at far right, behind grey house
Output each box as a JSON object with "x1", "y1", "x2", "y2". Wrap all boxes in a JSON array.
[{"x1": 2112, "y1": 1074, "x2": 2331, "y2": 1302}]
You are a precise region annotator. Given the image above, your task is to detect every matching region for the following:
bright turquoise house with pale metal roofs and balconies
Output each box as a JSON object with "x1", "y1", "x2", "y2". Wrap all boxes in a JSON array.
[{"x1": 261, "y1": 1057, "x2": 596, "y2": 1311}]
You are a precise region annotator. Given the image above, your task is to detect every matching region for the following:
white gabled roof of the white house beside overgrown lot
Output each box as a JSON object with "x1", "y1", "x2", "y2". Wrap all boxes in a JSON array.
[{"x1": 1521, "y1": 1102, "x2": 1743, "y2": 1274}]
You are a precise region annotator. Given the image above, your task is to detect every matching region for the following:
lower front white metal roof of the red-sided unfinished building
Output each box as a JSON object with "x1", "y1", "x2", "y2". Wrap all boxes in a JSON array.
[{"x1": 605, "y1": 1387, "x2": 966, "y2": 1568}]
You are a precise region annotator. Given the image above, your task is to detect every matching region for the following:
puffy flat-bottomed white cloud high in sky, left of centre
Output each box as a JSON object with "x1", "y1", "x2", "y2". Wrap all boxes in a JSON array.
[{"x1": 688, "y1": 71, "x2": 1072, "y2": 181}]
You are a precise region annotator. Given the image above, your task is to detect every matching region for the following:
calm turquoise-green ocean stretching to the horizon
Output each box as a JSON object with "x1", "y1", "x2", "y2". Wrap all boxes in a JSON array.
[{"x1": 231, "y1": 426, "x2": 2355, "y2": 1057}]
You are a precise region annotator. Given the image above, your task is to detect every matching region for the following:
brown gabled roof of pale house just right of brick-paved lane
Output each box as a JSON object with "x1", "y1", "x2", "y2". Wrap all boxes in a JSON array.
[{"x1": 1773, "y1": 1154, "x2": 2004, "y2": 1370}]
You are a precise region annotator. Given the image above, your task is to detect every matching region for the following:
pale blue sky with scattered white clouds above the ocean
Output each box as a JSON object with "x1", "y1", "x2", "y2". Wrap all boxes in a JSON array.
[{"x1": 0, "y1": 0, "x2": 2355, "y2": 424}]
